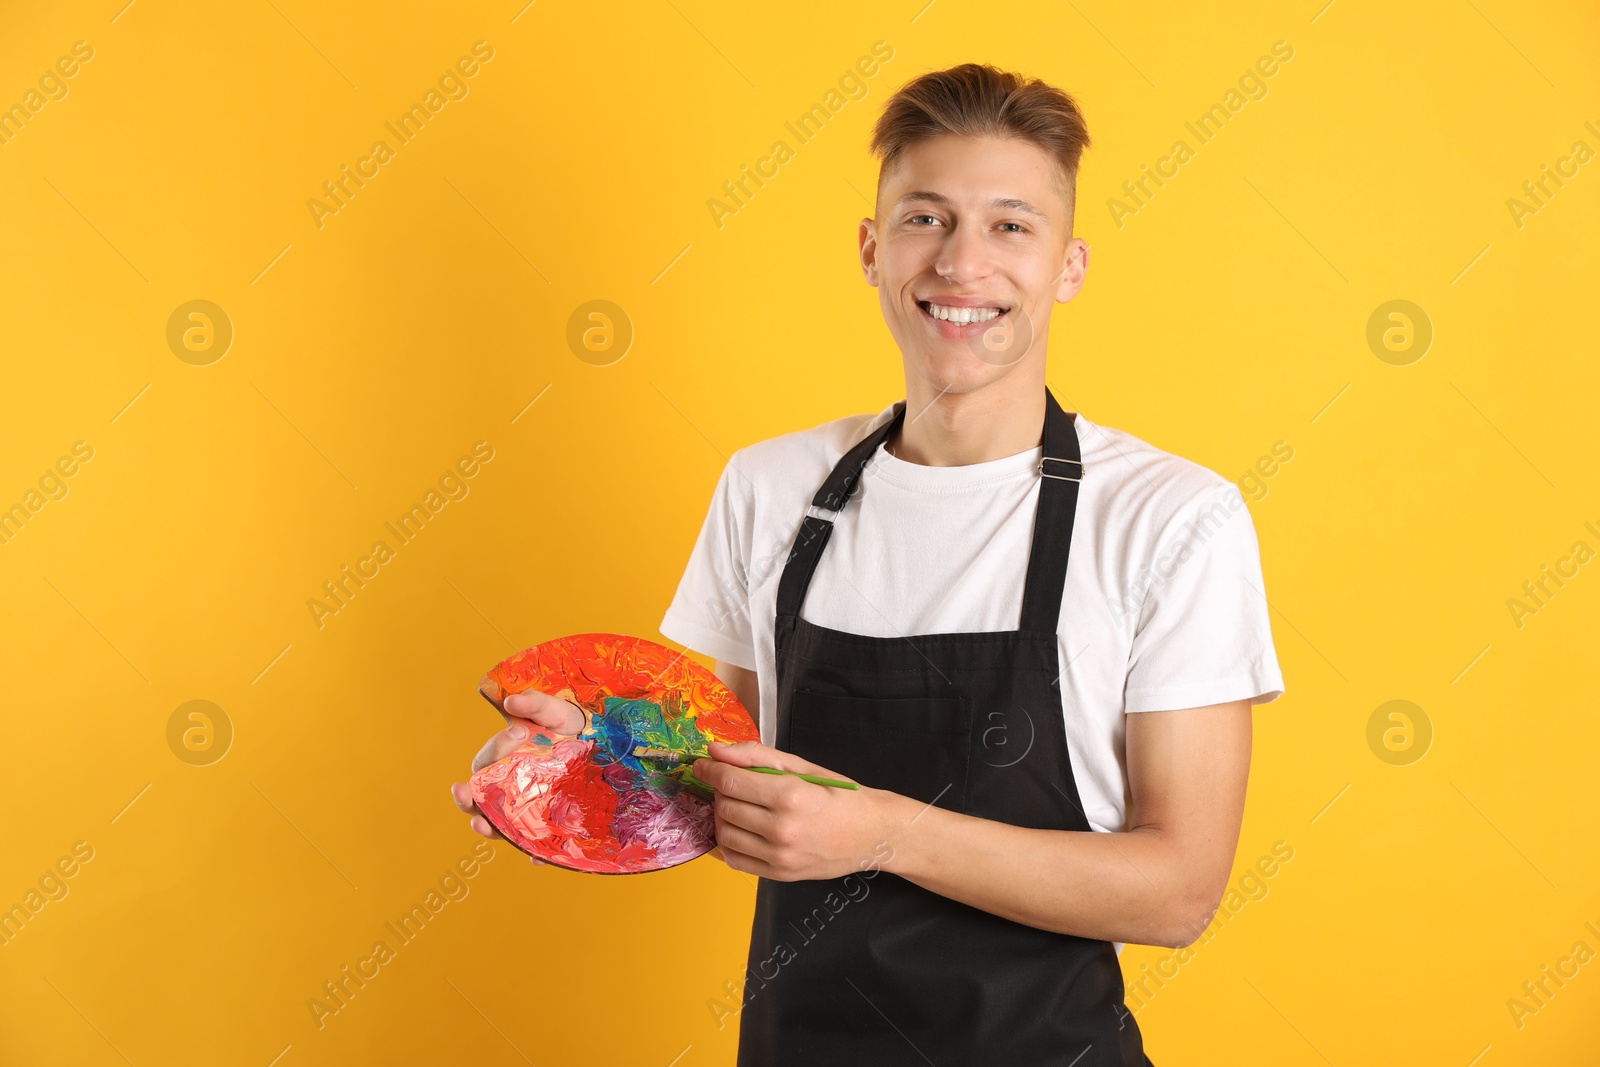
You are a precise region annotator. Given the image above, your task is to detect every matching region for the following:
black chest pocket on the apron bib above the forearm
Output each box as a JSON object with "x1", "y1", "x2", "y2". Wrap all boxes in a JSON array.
[{"x1": 784, "y1": 689, "x2": 973, "y2": 811}]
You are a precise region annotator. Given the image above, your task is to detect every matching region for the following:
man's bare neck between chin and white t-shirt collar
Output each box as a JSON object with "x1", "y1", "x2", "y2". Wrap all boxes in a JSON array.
[{"x1": 888, "y1": 374, "x2": 1045, "y2": 467}]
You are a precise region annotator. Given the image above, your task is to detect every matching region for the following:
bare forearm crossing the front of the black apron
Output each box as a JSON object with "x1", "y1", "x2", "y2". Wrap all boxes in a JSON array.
[{"x1": 883, "y1": 793, "x2": 1214, "y2": 947}]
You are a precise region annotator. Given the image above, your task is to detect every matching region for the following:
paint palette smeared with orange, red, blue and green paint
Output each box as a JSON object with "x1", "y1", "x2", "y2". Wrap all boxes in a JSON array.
[{"x1": 470, "y1": 633, "x2": 760, "y2": 875}]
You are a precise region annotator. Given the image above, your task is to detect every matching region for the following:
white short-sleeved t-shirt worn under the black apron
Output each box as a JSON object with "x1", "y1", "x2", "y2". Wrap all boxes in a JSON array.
[{"x1": 661, "y1": 405, "x2": 1283, "y2": 830}]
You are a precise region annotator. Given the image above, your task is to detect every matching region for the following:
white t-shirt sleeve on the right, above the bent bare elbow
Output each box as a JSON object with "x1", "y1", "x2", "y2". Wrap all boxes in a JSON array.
[{"x1": 1123, "y1": 483, "x2": 1283, "y2": 712}]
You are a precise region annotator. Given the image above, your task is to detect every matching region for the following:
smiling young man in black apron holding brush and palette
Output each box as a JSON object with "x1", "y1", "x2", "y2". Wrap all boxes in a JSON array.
[{"x1": 458, "y1": 64, "x2": 1283, "y2": 1067}]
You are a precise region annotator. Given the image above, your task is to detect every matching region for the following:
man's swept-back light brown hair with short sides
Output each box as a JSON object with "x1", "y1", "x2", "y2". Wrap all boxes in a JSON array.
[{"x1": 869, "y1": 62, "x2": 1090, "y2": 208}]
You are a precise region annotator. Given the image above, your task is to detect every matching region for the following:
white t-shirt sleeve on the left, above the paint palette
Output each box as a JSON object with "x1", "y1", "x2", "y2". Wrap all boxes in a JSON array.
[{"x1": 659, "y1": 453, "x2": 755, "y2": 670}]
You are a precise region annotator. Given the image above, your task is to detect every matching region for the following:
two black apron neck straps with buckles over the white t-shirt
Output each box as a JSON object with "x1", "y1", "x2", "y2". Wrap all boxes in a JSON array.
[{"x1": 778, "y1": 387, "x2": 1083, "y2": 633}]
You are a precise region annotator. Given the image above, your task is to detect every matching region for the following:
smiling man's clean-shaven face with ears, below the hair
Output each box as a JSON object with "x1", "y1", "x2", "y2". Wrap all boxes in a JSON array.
[{"x1": 861, "y1": 134, "x2": 1088, "y2": 392}]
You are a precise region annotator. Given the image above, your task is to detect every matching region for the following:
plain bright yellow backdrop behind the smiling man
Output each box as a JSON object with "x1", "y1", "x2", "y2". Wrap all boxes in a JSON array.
[{"x1": 0, "y1": 0, "x2": 1600, "y2": 1067}]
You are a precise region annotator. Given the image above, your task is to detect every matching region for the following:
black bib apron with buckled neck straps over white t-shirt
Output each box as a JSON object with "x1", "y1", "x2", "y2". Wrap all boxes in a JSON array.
[{"x1": 739, "y1": 390, "x2": 1150, "y2": 1067}]
